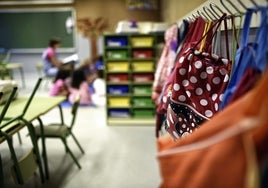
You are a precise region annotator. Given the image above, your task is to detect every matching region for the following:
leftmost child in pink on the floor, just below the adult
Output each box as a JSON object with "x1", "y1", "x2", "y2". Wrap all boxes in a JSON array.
[{"x1": 49, "y1": 69, "x2": 71, "y2": 99}]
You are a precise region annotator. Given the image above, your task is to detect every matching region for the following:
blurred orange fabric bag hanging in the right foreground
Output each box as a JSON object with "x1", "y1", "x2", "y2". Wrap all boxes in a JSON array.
[{"x1": 157, "y1": 71, "x2": 268, "y2": 188}]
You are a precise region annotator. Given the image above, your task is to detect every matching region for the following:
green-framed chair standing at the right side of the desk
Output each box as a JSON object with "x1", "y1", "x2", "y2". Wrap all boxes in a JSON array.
[{"x1": 35, "y1": 96, "x2": 85, "y2": 169}]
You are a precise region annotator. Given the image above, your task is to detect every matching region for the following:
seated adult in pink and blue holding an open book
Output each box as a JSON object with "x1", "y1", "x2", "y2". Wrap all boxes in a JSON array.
[{"x1": 42, "y1": 38, "x2": 62, "y2": 77}]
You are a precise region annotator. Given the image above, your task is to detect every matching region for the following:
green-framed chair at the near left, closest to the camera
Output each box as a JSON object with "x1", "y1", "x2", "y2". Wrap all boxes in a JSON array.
[{"x1": 0, "y1": 78, "x2": 44, "y2": 185}]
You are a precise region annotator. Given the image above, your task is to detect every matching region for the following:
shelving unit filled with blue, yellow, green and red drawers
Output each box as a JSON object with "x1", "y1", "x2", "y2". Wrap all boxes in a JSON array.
[{"x1": 104, "y1": 33, "x2": 164, "y2": 125}]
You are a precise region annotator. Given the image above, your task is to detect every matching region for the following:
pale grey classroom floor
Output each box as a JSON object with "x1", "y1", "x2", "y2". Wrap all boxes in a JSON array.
[{"x1": 0, "y1": 74, "x2": 160, "y2": 188}]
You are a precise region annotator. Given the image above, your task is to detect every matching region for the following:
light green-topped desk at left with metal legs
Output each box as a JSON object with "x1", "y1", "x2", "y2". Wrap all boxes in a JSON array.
[{"x1": 0, "y1": 96, "x2": 66, "y2": 182}]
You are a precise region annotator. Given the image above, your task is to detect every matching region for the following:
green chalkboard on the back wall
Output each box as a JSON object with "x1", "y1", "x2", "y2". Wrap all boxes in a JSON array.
[{"x1": 0, "y1": 9, "x2": 74, "y2": 50}]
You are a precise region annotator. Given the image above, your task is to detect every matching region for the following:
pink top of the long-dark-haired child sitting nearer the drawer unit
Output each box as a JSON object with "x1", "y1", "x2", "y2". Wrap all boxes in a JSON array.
[{"x1": 69, "y1": 81, "x2": 92, "y2": 105}]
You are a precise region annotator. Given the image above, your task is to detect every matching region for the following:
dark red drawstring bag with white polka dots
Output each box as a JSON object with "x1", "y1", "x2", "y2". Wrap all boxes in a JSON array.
[{"x1": 166, "y1": 49, "x2": 232, "y2": 138}]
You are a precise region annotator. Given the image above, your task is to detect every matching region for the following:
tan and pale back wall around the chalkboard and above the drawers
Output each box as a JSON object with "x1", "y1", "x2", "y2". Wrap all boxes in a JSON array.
[{"x1": 0, "y1": 0, "x2": 204, "y2": 74}]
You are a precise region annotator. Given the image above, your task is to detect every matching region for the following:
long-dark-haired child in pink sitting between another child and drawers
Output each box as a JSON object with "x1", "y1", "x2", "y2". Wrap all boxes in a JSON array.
[{"x1": 68, "y1": 68, "x2": 92, "y2": 105}]
